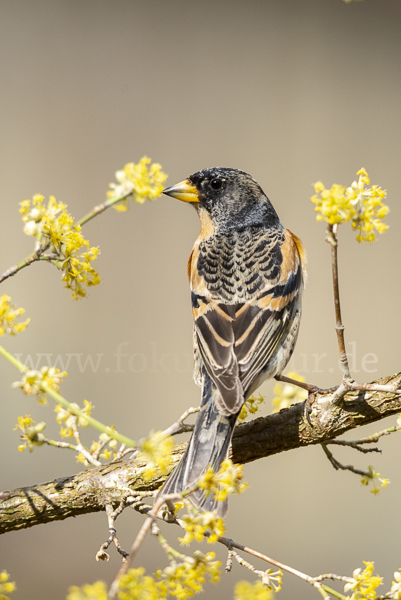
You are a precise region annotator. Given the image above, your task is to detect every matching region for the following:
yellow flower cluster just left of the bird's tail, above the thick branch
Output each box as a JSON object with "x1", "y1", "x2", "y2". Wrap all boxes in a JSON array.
[{"x1": 138, "y1": 431, "x2": 175, "y2": 480}]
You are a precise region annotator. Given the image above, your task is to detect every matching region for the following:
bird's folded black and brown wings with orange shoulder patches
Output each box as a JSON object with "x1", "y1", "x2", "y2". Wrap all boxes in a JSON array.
[{"x1": 191, "y1": 230, "x2": 305, "y2": 415}]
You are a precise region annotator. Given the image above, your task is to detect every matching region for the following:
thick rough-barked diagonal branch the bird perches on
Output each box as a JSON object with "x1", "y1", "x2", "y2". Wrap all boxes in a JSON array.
[{"x1": 0, "y1": 373, "x2": 401, "y2": 533}]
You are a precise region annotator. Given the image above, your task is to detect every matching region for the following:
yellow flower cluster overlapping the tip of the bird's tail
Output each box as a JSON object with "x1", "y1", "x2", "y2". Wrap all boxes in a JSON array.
[{"x1": 198, "y1": 458, "x2": 248, "y2": 501}]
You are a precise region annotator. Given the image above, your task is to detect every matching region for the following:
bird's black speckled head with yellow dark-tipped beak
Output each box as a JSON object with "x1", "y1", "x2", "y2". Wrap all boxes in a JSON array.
[{"x1": 163, "y1": 167, "x2": 280, "y2": 231}]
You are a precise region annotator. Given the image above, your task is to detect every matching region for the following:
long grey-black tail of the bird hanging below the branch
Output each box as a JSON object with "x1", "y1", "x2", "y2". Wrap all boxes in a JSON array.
[{"x1": 161, "y1": 374, "x2": 238, "y2": 517}]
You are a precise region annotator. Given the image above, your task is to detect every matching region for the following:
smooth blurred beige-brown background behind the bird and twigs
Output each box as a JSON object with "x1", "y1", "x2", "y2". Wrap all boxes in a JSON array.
[{"x1": 0, "y1": 0, "x2": 401, "y2": 600}]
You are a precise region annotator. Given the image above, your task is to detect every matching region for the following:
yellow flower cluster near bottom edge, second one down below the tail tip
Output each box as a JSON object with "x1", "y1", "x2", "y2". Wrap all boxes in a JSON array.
[{"x1": 155, "y1": 550, "x2": 221, "y2": 600}]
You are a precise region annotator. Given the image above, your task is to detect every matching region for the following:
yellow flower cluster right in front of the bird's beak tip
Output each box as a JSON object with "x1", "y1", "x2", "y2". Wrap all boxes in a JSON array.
[{"x1": 107, "y1": 156, "x2": 167, "y2": 211}]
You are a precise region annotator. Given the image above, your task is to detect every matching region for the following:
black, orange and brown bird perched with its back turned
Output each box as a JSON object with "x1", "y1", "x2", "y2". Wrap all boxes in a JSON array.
[{"x1": 161, "y1": 167, "x2": 306, "y2": 517}]
